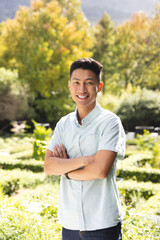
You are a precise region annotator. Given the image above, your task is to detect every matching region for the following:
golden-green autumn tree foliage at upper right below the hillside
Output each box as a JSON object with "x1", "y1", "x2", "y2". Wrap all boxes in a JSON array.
[{"x1": 94, "y1": 7, "x2": 160, "y2": 94}]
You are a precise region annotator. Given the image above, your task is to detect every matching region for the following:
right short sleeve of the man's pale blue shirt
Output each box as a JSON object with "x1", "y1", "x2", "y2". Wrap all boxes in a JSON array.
[{"x1": 98, "y1": 117, "x2": 126, "y2": 160}]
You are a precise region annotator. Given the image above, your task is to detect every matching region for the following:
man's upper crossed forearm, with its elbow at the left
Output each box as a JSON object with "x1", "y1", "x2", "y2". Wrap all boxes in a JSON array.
[{"x1": 44, "y1": 155, "x2": 95, "y2": 175}]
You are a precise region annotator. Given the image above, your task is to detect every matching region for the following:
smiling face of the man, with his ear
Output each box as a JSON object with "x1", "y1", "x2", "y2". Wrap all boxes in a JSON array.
[{"x1": 69, "y1": 68, "x2": 103, "y2": 108}]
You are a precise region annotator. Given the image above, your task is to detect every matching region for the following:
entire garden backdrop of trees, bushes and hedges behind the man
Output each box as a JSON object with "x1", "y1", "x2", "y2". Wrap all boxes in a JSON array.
[{"x1": 0, "y1": 0, "x2": 160, "y2": 240}]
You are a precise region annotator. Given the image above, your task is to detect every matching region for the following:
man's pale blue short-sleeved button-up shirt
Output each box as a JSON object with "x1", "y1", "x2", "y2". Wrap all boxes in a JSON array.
[{"x1": 48, "y1": 104, "x2": 125, "y2": 231}]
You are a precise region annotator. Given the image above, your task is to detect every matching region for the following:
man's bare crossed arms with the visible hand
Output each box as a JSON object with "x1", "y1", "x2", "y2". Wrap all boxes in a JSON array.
[{"x1": 44, "y1": 145, "x2": 117, "y2": 180}]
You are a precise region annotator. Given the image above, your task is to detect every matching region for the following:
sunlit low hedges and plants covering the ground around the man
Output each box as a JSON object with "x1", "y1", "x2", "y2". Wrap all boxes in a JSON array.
[{"x1": 0, "y1": 123, "x2": 160, "y2": 240}]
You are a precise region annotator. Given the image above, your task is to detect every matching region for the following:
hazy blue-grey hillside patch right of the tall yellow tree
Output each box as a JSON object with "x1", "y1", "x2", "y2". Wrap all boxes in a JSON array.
[{"x1": 82, "y1": 0, "x2": 160, "y2": 24}]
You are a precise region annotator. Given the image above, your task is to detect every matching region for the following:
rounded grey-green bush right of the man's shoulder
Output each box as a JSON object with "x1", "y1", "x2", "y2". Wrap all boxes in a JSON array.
[{"x1": 115, "y1": 89, "x2": 160, "y2": 131}]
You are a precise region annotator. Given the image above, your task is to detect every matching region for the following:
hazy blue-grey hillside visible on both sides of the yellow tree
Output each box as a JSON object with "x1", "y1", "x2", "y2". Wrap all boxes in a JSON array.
[{"x1": 0, "y1": 0, "x2": 160, "y2": 24}]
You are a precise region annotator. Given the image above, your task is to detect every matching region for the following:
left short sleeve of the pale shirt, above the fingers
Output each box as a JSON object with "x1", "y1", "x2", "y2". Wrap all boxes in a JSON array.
[{"x1": 47, "y1": 121, "x2": 63, "y2": 152}]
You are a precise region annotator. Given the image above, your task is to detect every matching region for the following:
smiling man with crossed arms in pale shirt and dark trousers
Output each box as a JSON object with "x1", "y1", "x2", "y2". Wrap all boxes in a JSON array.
[{"x1": 44, "y1": 58, "x2": 125, "y2": 240}]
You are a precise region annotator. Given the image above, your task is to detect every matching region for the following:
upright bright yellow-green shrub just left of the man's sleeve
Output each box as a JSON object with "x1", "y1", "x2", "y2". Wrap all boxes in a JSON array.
[{"x1": 32, "y1": 120, "x2": 52, "y2": 160}]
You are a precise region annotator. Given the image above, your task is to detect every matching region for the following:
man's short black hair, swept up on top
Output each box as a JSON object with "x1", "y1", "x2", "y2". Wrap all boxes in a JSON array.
[{"x1": 70, "y1": 58, "x2": 103, "y2": 82}]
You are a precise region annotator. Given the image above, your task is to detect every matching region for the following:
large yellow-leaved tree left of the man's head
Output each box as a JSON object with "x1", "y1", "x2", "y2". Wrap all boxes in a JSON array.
[{"x1": 1, "y1": 0, "x2": 92, "y2": 125}]
